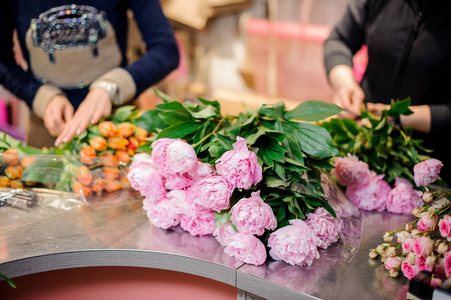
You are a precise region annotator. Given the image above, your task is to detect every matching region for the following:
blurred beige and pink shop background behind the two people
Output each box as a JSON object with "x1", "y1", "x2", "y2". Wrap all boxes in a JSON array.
[{"x1": 0, "y1": 0, "x2": 366, "y2": 139}]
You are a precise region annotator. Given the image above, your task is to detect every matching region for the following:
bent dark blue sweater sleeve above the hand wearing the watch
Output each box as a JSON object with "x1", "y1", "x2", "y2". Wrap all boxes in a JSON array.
[{"x1": 125, "y1": 0, "x2": 179, "y2": 95}]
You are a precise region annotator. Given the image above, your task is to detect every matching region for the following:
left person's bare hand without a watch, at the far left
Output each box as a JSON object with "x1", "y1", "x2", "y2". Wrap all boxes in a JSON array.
[{"x1": 44, "y1": 95, "x2": 74, "y2": 136}]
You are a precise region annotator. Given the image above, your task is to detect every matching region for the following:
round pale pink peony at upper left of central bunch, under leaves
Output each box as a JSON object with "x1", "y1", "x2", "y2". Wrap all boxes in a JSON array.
[{"x1": 166, "y1": 139, "x2": 197, "y2": 174}]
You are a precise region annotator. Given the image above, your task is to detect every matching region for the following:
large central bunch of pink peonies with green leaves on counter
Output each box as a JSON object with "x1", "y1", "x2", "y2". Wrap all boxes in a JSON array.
[{"x1": 128, "y1": 93, "x2": 341, "y2": 266}]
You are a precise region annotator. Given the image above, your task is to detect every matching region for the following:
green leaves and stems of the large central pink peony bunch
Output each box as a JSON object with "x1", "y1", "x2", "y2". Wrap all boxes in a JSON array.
[{"x1": 145, "y1": 91, "x2": 341, "y2": 227}]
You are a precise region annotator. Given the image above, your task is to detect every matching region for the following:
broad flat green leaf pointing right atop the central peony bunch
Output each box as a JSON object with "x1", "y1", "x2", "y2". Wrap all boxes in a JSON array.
[{"x1": 284, "y1": 100, "x2": 343, "y2": 122}]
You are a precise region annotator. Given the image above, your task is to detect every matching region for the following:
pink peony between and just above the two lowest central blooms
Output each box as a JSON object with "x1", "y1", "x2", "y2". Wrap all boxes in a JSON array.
[{"x1": 230, "y1": 191, "x2": 277, "y2": 235}]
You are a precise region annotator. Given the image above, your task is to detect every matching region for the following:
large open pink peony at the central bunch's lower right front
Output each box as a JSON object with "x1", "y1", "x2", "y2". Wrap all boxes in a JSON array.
[{"x1": 268, "y1": 219, "x2": 322, "y2": 266}]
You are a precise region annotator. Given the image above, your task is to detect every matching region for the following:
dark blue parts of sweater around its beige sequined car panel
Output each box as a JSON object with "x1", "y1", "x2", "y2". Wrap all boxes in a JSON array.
[{"x1": 0, "y1": 0, "x2": 179, "y2": 109}]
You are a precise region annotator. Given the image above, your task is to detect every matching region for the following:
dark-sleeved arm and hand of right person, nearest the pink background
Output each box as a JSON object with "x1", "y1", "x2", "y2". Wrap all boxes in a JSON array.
[{"x1": 324, "y1": 0, "x2": 367, "y2": 118}]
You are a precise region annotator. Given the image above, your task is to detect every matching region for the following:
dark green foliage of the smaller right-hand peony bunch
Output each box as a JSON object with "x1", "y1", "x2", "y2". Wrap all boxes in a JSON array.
[{"x1": 321, "y1": 98, "x2": 438, "y2": 184}]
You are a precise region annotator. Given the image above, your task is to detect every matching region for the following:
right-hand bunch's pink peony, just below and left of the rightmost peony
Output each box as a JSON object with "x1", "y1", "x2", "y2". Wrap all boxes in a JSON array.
[{"x1": 387, "y1": 177, "x2": 423, "y2": 215}]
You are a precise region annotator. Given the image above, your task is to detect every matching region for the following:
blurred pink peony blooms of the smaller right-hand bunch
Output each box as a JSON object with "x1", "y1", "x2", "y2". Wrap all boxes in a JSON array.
[{"x1": 331, "y1": 154, "x2": 443, "y2": 214}]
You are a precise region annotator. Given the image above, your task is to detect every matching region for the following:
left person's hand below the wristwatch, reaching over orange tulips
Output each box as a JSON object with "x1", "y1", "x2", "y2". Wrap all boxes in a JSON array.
[{"x1": 55, "y1": 88, "x2": 112, "y2": 146}]
